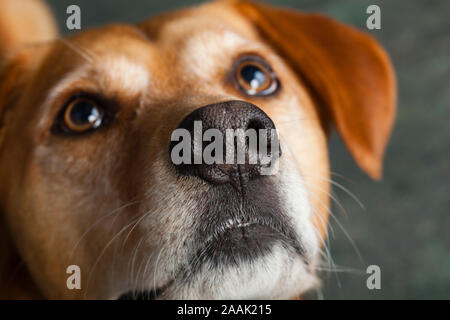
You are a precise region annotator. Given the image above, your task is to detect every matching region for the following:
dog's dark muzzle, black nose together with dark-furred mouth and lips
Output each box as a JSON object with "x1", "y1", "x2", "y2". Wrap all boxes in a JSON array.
[{"x1": 121, "y1": 101, "x2": 305, "y2": 299}]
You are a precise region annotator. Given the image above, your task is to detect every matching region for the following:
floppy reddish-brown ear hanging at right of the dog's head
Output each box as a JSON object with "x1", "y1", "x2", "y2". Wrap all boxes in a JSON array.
[{"x1": 232, "y1": 1, "x2": 396, "y2": 179}]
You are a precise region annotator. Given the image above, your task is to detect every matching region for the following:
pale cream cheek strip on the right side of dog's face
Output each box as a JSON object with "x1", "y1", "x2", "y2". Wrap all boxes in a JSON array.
[{"x1": 266, "y1": 77, "x2": 330, "y2": 242}]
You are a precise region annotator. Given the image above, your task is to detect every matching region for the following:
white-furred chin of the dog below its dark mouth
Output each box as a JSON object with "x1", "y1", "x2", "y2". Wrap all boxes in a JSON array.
[{"x1": 173, "y1": 242, "x2": 316, "y2": 300}]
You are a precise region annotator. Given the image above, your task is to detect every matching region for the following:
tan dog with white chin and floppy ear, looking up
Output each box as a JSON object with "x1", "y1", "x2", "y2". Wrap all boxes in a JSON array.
[{"x1": 0, "y1": 0, "x2": 396, "y2": 299}]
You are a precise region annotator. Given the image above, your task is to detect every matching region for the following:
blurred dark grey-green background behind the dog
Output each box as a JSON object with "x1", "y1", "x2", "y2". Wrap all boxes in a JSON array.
[{"x1": 45, "y1": 0, "x2": 450, "y2": 299}]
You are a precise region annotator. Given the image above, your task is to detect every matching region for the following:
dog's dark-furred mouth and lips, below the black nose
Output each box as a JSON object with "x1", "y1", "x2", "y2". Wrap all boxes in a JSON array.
[{"x1": 119, "y1": 178, "x2": 308, "y2": 300}]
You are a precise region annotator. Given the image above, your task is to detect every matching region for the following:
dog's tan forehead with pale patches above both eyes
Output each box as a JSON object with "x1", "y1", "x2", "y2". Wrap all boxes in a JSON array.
[{"x1": 41, "y1": 3, "x2": 264, "y2": 105}]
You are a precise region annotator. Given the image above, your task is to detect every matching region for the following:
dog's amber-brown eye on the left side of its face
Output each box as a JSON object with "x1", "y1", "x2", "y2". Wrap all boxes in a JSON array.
[{"x1": 61, "y1": 98, "x2": 104, "y2": 133}]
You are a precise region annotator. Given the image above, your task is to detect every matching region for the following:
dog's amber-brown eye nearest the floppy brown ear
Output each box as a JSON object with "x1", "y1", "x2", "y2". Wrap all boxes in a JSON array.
[{"x1": 235, "y1": 56, "x2": 279, "y2": 96}]
